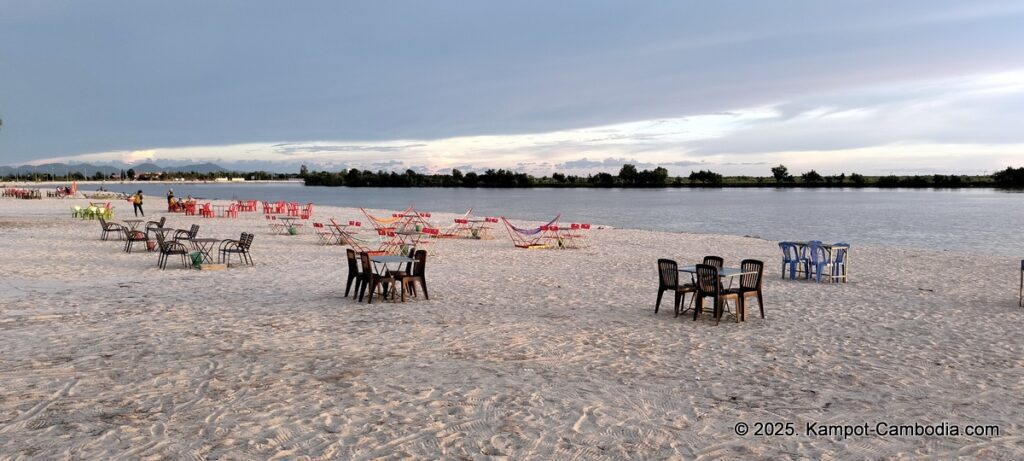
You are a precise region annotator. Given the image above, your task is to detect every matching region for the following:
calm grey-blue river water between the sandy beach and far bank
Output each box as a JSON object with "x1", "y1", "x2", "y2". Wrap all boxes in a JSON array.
[{"x1": 108, "y1": 183, "x2": 1024, "y2": 256}]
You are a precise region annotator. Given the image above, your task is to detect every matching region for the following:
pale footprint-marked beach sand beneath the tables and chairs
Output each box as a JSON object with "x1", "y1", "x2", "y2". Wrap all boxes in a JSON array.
[{"x1": 0, "y1": 193, "x2": 1024, "y2": 459}]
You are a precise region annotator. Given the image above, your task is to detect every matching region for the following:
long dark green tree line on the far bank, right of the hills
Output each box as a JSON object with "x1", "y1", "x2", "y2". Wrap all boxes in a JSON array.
[{"x1": 299, "y1": 164, "x2": 1024, "y2": 188}]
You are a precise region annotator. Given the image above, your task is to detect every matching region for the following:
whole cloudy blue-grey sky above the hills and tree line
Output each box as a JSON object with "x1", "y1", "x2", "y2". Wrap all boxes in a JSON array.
[{"x1": 0, "y1": 0, "x2": 1024, "y2": 175}]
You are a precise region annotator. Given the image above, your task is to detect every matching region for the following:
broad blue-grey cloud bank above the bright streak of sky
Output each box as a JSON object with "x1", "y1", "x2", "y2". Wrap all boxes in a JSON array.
[{"x1": 0, "y1": 0, "x2": 1024, "y2": 164}]
